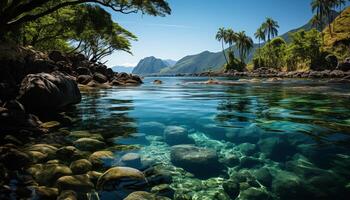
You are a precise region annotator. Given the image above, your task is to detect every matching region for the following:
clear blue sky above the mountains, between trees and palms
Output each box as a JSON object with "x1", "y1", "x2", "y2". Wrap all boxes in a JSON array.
[{"x1": 107, "y1": 0, "x2": 344, "y2": 67}]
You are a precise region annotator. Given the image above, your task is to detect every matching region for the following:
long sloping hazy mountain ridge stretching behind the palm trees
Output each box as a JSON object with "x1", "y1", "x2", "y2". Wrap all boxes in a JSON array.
[{"x1": 161, "y1": 11, "x2": 338, "y2": 75}]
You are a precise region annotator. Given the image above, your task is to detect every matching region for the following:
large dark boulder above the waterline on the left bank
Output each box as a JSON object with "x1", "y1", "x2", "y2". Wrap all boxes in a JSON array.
[{"x1": 18, "y1": 71, "x2": 81, "y2": 110}]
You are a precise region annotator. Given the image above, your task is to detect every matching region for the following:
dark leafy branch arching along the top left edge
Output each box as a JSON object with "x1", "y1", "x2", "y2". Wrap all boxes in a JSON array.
[{"x1": 0, "y1": 0, "x2": 171, "y2": 37}]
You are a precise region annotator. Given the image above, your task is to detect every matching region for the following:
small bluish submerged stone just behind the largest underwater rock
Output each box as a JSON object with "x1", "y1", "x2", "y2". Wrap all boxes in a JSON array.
[{"x1": 164, "y1": 126, "x2": 194, "y2": 145}]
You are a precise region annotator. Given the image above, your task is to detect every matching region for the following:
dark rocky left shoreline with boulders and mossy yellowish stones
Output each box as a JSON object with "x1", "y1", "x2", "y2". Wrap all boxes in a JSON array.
[{"x1": 0, "y1": 45, "x2": 171, "y2": 200}]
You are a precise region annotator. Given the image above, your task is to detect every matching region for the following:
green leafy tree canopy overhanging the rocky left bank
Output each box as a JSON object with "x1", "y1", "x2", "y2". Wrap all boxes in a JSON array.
[{"x1": 0, "y1": 0, "x2": 171, "y2": 61}]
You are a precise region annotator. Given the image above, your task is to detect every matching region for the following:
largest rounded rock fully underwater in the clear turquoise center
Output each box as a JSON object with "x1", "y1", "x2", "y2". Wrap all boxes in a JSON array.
[{"x1": 170, "y1": 145, "x2": 222, "y2": 178}]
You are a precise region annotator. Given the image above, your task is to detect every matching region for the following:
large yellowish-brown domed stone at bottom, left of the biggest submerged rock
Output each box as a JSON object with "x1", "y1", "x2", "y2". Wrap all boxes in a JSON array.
[{"x1": 97, "y1": 167, "x2": 147, "y2": 191}]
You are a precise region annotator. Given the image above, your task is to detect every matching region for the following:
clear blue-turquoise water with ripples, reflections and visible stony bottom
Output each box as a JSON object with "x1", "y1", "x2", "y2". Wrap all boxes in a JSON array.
[{"x1": 69, "y1": 77, "x2": 350, "y2": 199}]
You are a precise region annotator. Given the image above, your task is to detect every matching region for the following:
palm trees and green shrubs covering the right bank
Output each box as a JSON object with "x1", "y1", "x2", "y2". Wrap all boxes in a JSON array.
[{"x1": 211, "y1": 0, "x2": 350, "y2": 78}]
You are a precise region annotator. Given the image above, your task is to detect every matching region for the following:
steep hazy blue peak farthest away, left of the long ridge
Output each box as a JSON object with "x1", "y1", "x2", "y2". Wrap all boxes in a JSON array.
[{"x1": 132, "y1": 56, "x2": 170, "y2": 75}]
